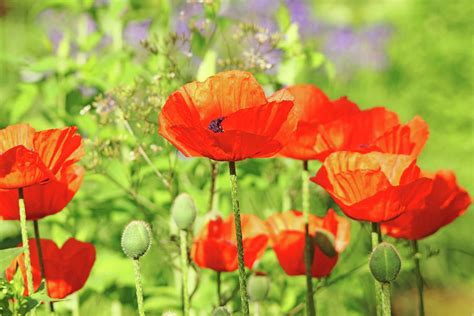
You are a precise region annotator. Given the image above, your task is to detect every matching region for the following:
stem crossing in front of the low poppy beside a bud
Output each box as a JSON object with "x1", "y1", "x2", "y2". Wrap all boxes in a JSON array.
[{"x1": 301, "y1": 160, "x2": 316, "y2": 316}]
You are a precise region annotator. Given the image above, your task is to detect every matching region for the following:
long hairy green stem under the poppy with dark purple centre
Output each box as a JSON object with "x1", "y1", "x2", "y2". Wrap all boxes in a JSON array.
[{"x1": 229, "y1": 161, "x2": 250, "y2": 316}]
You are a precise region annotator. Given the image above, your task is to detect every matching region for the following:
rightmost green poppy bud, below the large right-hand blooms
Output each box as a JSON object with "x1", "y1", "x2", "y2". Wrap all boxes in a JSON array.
[{"x1": 369, "y1": 242, "x2": 402, "y2": 282}]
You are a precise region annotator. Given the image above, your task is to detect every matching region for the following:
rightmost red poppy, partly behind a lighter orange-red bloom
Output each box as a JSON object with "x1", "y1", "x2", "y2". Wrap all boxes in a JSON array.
[{"x1": 382, "y1": 170, "x2": 471, "y2": 240}]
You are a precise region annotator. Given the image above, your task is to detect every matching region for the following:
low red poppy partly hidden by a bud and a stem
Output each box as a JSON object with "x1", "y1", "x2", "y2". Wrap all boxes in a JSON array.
[{"x1": 266, "y1": 209, "x2": 350, "y2": 278}]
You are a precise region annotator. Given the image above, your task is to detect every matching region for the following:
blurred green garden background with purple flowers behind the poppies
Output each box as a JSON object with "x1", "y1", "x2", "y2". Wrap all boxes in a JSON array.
[{"x1": 0, "y1": 0, "x2": 474, "y2": 316}]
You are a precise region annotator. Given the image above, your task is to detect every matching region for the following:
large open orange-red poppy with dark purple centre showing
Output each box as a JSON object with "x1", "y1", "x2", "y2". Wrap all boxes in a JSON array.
[{"x1": 159, "y1": 71, "x2": 296, "y2": 161}]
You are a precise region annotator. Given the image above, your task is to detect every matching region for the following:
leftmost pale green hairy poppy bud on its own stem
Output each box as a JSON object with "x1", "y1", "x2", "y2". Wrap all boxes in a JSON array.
[{"x1": 122, "y1": 221, "x2": 152, "y2": 259}]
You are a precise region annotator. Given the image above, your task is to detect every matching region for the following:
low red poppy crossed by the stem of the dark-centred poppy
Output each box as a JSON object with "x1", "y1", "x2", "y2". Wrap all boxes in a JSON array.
[{"x1": 191, "y1": 214, "x2": 268, "y2": 271}]
